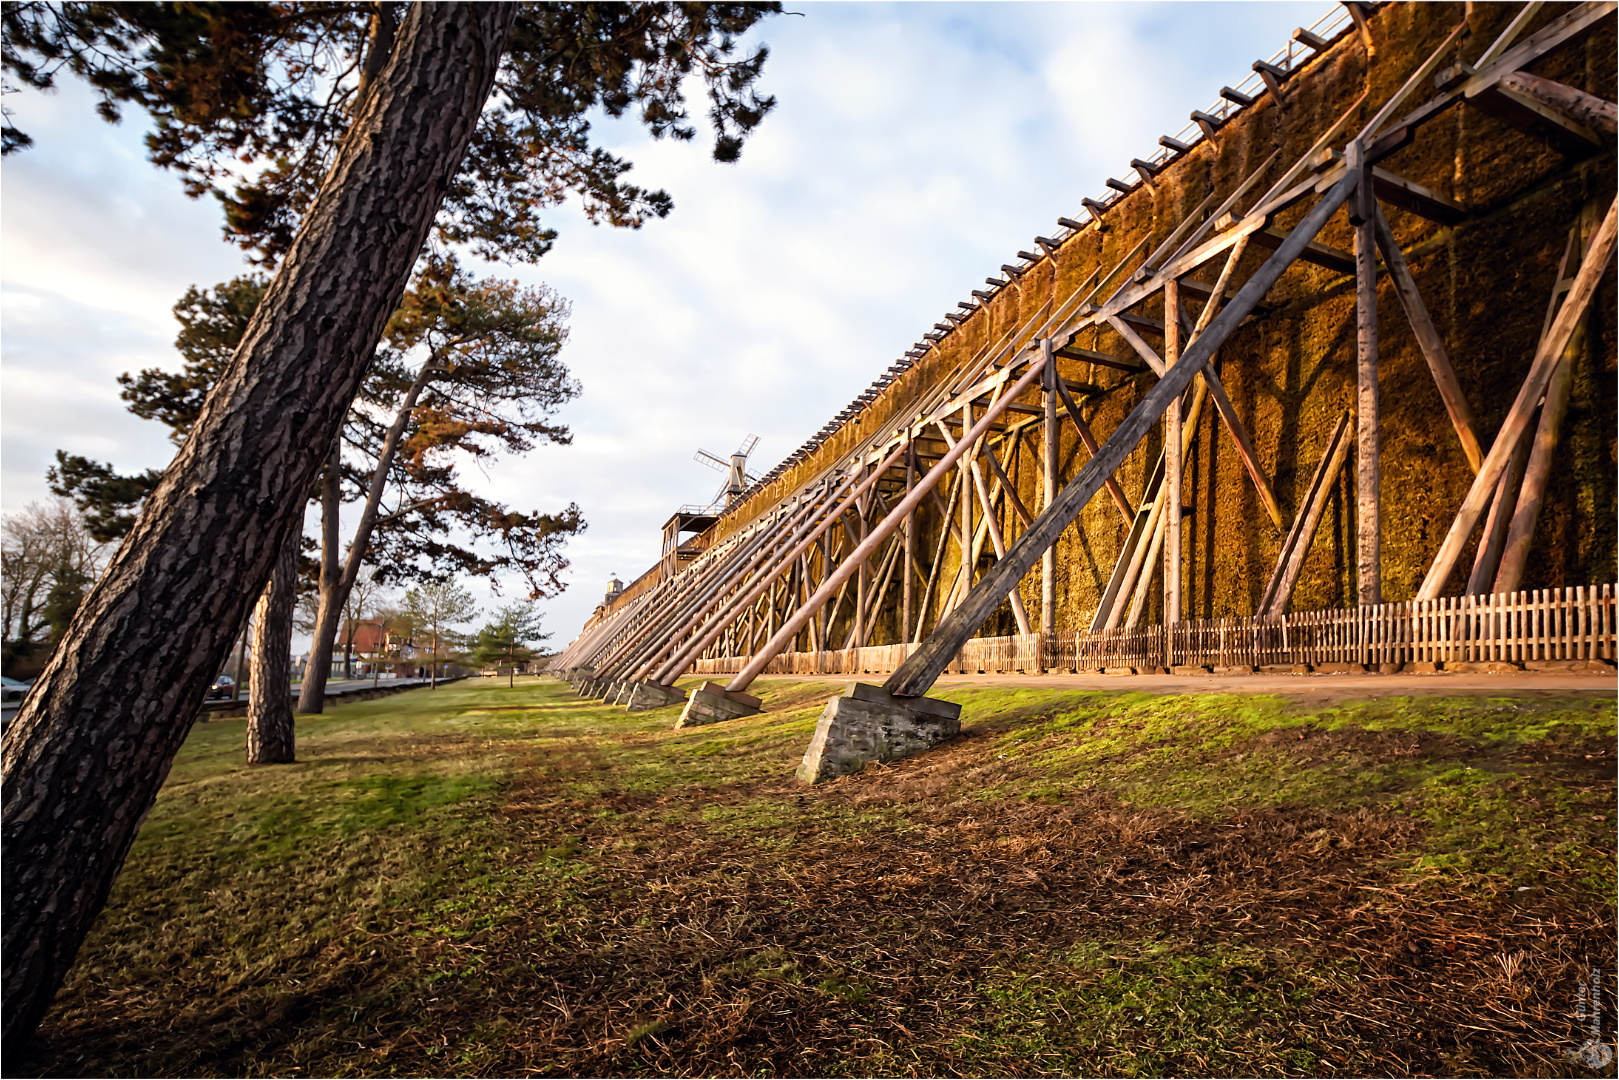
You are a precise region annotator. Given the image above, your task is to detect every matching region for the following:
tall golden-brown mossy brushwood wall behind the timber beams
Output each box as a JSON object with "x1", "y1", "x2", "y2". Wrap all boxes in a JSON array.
[{"x1": 702, "y1": 3, "x2": 1619, "y2": 644}]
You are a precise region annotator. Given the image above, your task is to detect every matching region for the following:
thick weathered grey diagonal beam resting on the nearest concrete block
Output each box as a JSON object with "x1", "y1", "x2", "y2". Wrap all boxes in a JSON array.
[{"x1": 884, "y1": 165, "x2": 1355, "y2": 698}]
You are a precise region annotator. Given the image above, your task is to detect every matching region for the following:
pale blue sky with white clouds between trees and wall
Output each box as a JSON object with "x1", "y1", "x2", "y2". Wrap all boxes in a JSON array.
[{"x1": 0, "y1": 0, "x2": 1331, "y2": 649}]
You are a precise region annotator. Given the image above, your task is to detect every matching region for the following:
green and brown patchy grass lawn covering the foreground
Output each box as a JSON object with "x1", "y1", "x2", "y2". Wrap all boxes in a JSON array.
[{"x1": 15, "y1": 678, "x2": 1616, "y2": 1077}]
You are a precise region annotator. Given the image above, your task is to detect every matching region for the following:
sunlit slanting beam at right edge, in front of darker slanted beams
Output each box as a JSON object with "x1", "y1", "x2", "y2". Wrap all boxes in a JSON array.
[{"x1": 1417, "y1": 194, "x2": 1619, "y2": 599}]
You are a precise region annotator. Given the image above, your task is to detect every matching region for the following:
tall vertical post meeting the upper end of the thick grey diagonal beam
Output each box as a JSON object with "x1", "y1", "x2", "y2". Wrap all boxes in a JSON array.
[{"x1": 1347, "y1": 141, "x2": 1383, "y2": 606}]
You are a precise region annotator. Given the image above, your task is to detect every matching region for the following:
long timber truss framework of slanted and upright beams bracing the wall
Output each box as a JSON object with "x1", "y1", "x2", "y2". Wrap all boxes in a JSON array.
[{"x1": 552, "y1": 2, "x2": 1616, "y2": 704}]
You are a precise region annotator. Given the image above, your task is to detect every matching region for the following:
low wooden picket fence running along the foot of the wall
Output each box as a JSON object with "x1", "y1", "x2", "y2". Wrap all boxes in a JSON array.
[{"x1": 695, "y1": 585, "x2": 1619, "y2": 675}]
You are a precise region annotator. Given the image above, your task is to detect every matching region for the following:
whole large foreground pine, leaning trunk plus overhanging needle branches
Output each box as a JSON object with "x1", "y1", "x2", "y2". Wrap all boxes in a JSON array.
[{"x1": 0, "y1": 2, "x2": 779, "y2": 1052}]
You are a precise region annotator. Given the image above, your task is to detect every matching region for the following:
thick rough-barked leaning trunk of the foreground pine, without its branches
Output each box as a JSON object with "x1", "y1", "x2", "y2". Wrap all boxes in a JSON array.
[{"x1": 0, "y1": 3, "x2": 515, "y2": 1052}]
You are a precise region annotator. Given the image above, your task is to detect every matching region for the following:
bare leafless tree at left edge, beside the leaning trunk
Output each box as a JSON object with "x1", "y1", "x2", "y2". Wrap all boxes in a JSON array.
[{"x1": 0, "y1": 499, "x2": 105, "y2": 677}]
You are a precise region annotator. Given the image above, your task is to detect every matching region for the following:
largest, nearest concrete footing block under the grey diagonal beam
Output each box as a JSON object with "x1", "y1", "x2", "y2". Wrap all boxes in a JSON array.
[{"x1": 797, "y1": 683, "x2": 962, "y2": 784}]
